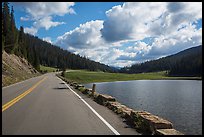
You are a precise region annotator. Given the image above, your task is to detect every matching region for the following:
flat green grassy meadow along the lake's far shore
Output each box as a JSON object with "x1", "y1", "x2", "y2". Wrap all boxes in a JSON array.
[{"x1": 62, "y1": 70, "x2": 201, "y2": 83}]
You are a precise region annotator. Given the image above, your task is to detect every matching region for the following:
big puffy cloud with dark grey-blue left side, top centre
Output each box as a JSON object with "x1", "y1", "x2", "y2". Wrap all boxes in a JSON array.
[{"x1": 101, "y1": 2, "x2": 166, "y2": 42}]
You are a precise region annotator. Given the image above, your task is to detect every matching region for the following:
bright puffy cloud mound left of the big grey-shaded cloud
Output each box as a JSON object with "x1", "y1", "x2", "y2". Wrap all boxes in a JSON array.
[{"x1": 56, "y1": 20, "x2": 104, "y2": 49}]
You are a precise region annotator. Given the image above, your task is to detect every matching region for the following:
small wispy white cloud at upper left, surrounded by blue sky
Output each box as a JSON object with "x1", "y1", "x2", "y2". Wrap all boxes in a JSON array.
[{"x1": 14, "y1": 2, "x2": 76, "y2": 34}]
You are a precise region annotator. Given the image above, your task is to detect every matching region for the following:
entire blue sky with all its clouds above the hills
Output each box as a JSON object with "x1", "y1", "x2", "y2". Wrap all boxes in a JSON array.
[{"x1": 10, "y1": 2, "x2": 202, "y2": 67}]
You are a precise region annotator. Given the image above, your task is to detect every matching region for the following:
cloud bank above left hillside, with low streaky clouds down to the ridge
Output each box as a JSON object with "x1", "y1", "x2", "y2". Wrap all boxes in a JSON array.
[{"x1": 55, "y1": 20, "x2": 137, "y2": 67}]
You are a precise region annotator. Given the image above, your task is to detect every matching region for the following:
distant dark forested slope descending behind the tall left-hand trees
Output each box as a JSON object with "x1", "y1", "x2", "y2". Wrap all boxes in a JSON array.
[{"x1": 26, "y1": 34, "x2": 116, "y2": 72}]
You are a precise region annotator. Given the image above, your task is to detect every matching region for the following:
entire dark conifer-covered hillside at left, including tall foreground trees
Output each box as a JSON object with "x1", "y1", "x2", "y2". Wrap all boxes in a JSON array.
[{"x1": 2, "y1": 2, "x2": 116, "y2": 72}]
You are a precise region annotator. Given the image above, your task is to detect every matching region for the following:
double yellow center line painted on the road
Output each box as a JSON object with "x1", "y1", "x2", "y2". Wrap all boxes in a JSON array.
[{"x1": 2, "y1": 77, "x2": 47, "y2": 112}]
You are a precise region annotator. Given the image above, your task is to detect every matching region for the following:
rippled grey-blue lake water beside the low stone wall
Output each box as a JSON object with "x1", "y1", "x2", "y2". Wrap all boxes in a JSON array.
[{"x1": 84, "y1": 80, "x2": 202, "y2": 135}]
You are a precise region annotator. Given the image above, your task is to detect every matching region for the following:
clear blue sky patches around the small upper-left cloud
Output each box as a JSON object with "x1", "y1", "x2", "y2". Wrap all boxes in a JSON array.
[{"x1": 11, "y1": 2, "x2": 123, "y2": 41}]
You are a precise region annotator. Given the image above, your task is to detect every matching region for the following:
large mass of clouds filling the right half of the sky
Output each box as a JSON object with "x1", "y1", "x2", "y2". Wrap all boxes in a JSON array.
[{"x1": 101, "y1": 2, "x2": 202, "y2": 66}]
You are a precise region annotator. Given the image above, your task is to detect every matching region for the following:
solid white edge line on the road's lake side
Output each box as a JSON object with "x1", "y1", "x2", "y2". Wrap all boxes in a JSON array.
[{"x1": 57, "y1": 77, "x2": 120, "y2": 135}]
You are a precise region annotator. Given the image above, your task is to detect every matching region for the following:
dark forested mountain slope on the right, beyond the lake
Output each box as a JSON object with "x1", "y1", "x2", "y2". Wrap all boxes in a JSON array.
[{"x1": 121, "y1": 45, "x2": 202, "y2": 76}]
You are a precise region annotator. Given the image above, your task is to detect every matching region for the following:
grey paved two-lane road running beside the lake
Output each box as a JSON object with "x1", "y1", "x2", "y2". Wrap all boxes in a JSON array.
[{"x1": 2, "y1": 73, "x2": 138, "y2": 135}]
